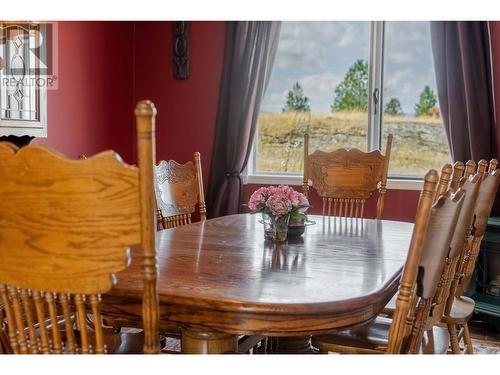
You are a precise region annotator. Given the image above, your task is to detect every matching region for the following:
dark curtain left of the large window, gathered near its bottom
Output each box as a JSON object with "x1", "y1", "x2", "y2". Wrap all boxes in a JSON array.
[{"x1": 207, "y1": 21, "x2": 281, "y2": 217}]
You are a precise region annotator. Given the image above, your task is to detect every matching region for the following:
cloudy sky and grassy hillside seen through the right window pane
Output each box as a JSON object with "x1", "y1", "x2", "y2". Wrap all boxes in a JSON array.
[{"x1": 382, "y1": 22, "x2": 450, "y2": 176}]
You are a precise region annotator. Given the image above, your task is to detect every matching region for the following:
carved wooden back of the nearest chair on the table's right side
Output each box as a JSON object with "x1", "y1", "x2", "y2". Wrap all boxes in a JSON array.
[{"x1": 387, "y1": 170, "x2": 465, "y2": 354}]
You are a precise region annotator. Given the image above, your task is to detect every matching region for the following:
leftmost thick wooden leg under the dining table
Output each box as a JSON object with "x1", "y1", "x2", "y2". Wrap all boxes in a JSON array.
[{"x1": 181, "y1": 328, "x2": 238, "y2": 354}]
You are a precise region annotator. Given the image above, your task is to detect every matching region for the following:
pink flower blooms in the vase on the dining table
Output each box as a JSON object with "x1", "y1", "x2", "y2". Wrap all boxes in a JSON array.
[{"x1": 248, "y1": 185, "x2": 309, "y2": 219}]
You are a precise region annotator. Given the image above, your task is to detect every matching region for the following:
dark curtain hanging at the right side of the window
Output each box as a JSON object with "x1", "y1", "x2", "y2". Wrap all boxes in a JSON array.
[{"x1": 431, "y1": 21, "x2": 498, "y2": 162}]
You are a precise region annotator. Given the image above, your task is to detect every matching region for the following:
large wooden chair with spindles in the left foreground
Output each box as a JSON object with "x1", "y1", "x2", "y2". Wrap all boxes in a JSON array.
[{"x1": 0, "y1": 101, "x2": 159, "y2": 354}]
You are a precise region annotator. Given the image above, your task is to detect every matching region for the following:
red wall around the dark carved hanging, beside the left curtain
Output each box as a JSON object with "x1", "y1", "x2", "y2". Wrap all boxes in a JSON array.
[{"x1": 134, "y1": 22, "x2": 225, "y2": 194}]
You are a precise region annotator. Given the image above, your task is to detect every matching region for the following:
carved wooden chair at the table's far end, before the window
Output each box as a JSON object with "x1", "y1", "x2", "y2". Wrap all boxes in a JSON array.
[{"x1": 302, "y1": 133, "x2": 392, "y2": 219}]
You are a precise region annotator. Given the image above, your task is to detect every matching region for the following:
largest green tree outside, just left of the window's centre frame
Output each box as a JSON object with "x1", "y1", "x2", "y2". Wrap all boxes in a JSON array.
[{"x1": 331, "y1": 59, "x2": 368, "y2": 112}]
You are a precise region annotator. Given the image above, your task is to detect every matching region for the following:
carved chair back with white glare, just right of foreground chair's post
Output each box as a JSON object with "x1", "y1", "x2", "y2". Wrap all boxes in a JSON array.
[{"x1": 154, "y1": 152, "x2": 206, "y2": 229}]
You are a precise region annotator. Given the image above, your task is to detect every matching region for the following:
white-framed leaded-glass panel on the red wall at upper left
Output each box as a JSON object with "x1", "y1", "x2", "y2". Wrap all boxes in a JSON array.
[{"x1": 0, "y1": 22, "x2": 47, "y2": 137}]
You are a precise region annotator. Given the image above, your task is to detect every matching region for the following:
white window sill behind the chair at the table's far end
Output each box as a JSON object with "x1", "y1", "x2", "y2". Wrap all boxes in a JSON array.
[{"x1": 243, "y1": 174, "x2": 423, "y2": 190}]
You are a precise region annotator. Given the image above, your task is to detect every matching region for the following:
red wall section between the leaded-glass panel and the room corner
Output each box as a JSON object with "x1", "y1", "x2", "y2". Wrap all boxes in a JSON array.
[{"x1": 34, "y1": 22, "x2": 135, "y2": 161}]
